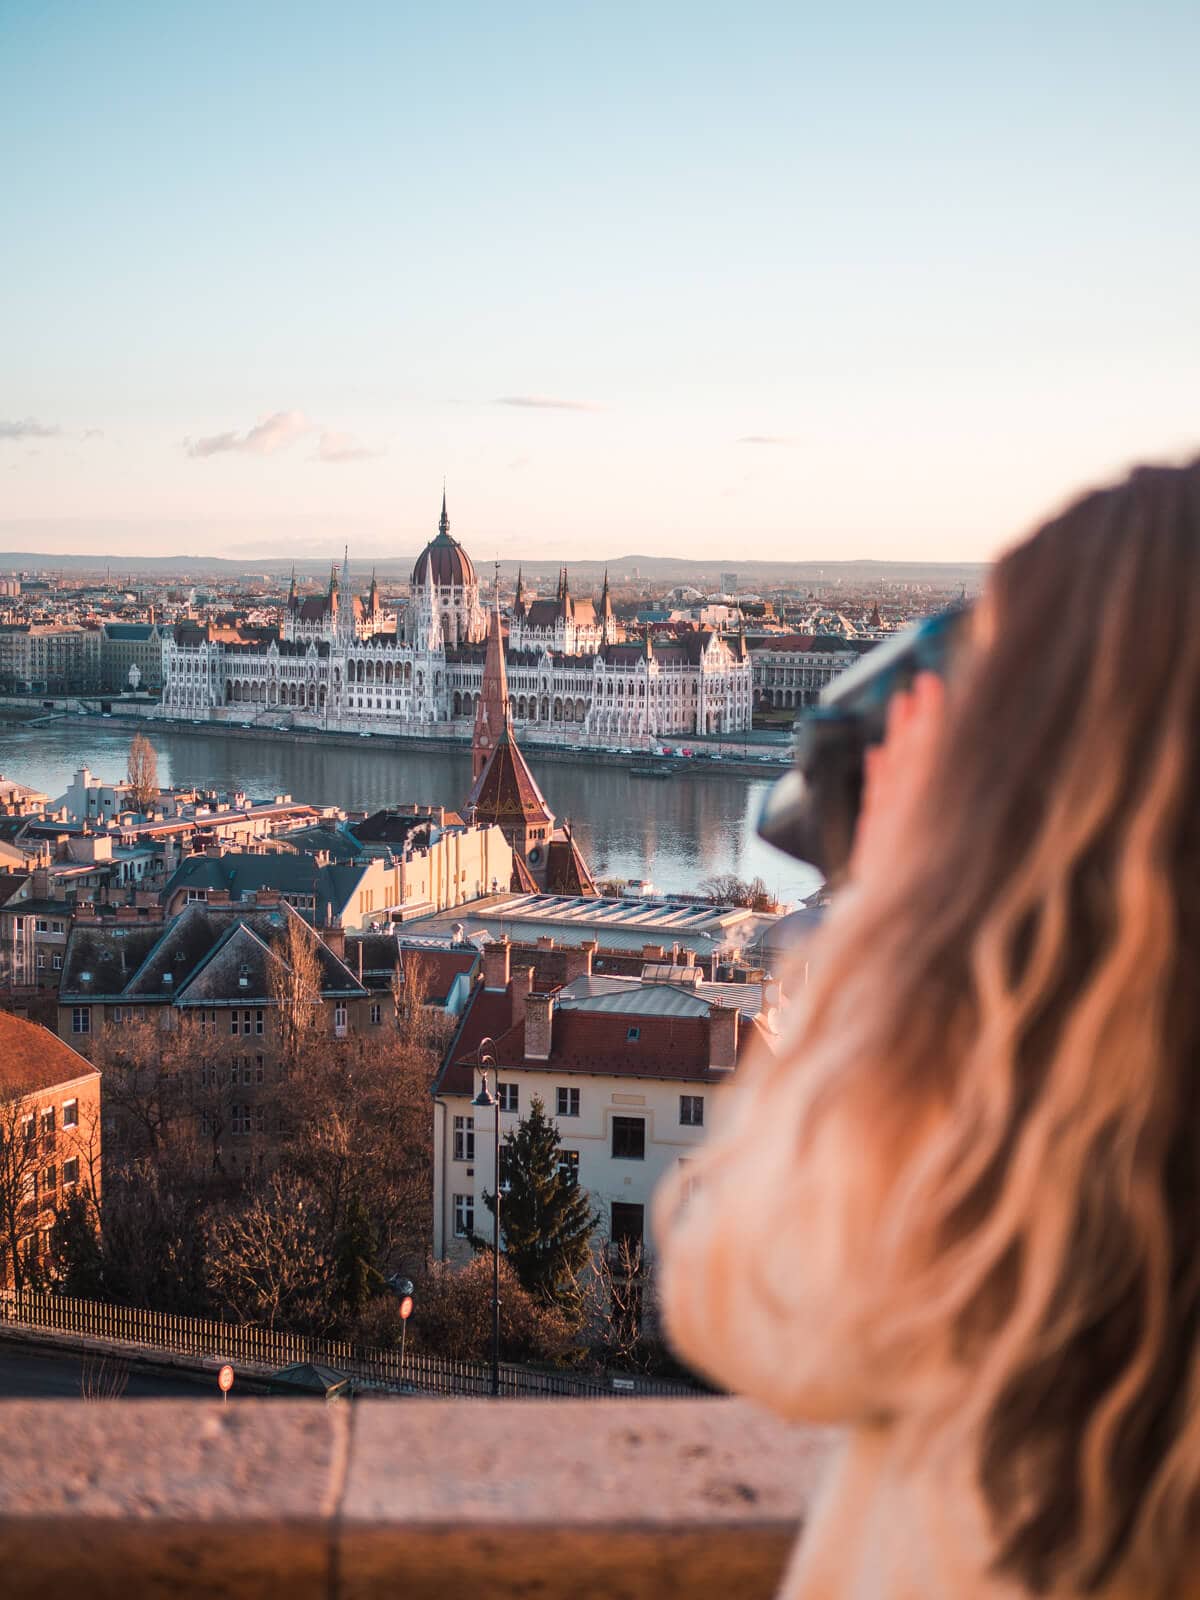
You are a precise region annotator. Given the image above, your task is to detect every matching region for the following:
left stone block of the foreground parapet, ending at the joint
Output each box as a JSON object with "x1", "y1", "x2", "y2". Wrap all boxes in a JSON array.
[{"x1": 0, "y1": 1400, "x2": 350, "y2": 1600}]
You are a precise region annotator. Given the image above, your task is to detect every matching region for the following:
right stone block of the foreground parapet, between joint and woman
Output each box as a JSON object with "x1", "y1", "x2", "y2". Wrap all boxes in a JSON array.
[{"x1": 338, "y1": 1400, "x2": 829, "y2": 1600}]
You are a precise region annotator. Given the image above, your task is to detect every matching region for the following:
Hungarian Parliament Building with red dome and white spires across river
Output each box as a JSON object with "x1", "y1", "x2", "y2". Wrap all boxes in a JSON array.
[{"x1": 162, "y1": 496, "x2": 752, "y2": 749}]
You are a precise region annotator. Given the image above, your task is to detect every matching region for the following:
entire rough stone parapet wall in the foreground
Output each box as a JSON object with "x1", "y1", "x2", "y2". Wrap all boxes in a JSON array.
[{"x1": 0, "y1": 1397, "x2": 829, "y2": 1600}]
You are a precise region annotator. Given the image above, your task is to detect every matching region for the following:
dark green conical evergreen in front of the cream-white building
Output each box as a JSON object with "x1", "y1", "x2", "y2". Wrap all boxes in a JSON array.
[{"x1": 483, "y1": 1096, "x2": 598, "y2": 1304}]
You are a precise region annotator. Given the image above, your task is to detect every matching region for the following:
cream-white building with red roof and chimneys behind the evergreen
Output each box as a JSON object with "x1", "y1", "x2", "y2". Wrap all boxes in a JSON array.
[{"x1": 434, "y1": 941, "x2": 768, "y2": 1261}]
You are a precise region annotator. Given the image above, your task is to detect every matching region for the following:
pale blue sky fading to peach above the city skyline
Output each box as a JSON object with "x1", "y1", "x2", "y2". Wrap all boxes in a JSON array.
[{"x1": 0, "y1": 0, "x2": 1200, "y2": 563}]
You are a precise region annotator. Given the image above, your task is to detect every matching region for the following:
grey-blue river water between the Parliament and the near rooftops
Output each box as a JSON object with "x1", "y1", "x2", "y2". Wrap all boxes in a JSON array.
[{"x1": 0, "y1": 722, "x2": 821, "y2": 902}]
